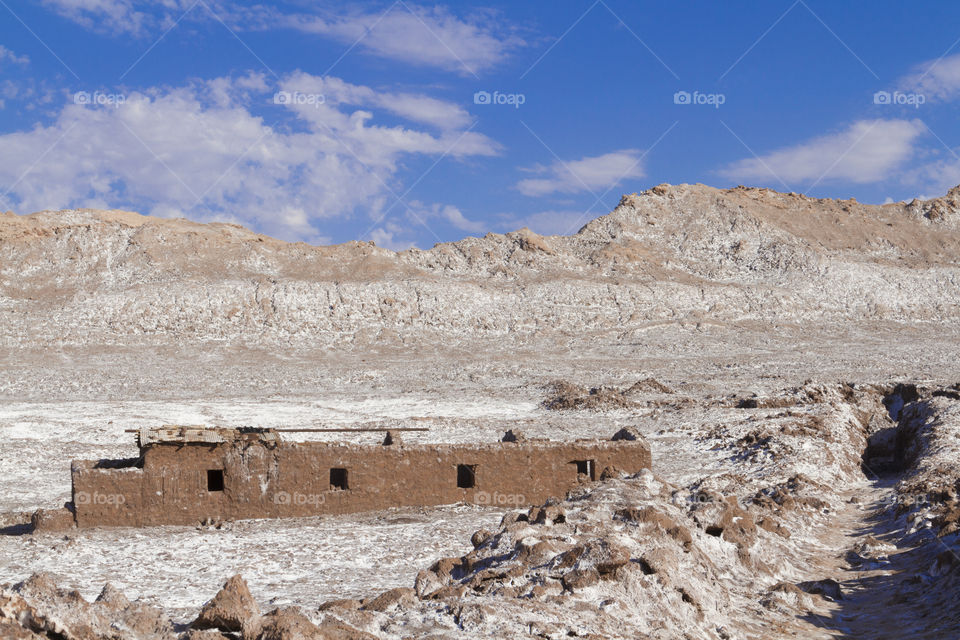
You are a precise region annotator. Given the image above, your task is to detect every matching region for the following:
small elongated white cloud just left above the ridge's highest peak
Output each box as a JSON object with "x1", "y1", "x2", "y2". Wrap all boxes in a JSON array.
[{"x1": 516, "y1": 149, "x2": 645, "y2": 196}]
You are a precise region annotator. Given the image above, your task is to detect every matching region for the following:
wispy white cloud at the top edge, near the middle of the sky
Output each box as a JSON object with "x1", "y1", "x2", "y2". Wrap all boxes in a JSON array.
[{"x1": 276, "y1": 3, "x2": 524, "y2": 74}]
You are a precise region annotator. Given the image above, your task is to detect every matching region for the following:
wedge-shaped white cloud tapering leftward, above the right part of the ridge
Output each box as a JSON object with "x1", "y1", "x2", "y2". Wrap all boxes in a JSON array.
[{"x1": 719, "y1": 120, "x2": 926, "y2": 183}]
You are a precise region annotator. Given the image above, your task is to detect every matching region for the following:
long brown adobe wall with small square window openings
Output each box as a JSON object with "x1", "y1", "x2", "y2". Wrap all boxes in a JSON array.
[{"x1": 72, "y1": 440, "x2": 651, "y2": 527}]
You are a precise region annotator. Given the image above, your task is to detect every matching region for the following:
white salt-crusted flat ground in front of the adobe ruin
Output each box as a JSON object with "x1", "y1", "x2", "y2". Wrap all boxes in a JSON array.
[{"x1": 0, "y1": 505, "x2": 503, "y2": 622}]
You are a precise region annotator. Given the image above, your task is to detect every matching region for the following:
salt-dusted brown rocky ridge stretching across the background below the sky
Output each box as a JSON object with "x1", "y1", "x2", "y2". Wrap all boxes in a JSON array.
[{"x1": 0, "y1": 185, "x2": 960, "y2": 347}]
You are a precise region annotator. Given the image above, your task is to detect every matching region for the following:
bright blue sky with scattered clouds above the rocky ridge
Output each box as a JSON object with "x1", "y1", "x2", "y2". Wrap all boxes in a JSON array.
[{"x1": 0, "y1": 0, "x2": 960, "y2": 249}]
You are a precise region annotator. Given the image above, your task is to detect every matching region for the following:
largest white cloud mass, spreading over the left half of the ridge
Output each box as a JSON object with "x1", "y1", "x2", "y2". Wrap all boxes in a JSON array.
[{"x1": 0, "y1": 74, "x2": 496, "y2": 240}]
